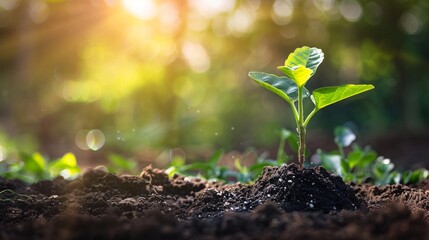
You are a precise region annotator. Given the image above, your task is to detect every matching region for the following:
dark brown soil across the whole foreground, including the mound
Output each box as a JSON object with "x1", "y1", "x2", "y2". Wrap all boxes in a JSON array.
[{"x1": 0, "y1": 164, "x2": 429, "y2": 240}]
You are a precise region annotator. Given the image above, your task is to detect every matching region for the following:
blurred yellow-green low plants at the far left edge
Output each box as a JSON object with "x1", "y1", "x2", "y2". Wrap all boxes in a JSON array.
[{"x1": 0, "y1": 152, "x2": 81, "y2": 183}]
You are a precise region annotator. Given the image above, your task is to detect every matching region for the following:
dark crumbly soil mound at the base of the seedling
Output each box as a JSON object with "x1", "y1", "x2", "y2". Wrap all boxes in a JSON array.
[{"x1": 248, "y1": 164, "x2": 365, "y2": 213}]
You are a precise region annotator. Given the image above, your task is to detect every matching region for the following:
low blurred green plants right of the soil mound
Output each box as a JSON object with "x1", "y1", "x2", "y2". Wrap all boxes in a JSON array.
[{"x1": 314, "y1": 127, "x2": 429, "y2": 185}]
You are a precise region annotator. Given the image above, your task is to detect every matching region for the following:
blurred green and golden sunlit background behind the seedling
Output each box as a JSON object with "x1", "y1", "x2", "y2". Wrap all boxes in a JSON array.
[{"x1": 0, "y1": 0, "x2": 429, "y2": 167}]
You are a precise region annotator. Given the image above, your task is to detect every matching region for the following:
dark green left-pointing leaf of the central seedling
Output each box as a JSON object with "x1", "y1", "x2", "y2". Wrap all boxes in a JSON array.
[{"x1": 249, "y1": 72, "x2": 310, "y2": 104}]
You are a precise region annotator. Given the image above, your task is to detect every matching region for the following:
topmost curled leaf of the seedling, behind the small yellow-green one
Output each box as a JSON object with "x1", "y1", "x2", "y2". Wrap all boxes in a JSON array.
[{"x1": 279, "y1": 46, "x2": 325, "y2": 76}]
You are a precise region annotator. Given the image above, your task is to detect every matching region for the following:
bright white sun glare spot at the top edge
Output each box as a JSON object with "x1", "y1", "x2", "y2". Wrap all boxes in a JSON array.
[{"x1": 122, "y1": 0, "x2": 157, "y2": 20}]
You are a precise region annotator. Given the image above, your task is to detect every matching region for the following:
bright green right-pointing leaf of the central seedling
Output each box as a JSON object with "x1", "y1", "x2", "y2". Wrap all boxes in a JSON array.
[{"x1": 313, "y1": 84, "x2": 374, "y2": 109}]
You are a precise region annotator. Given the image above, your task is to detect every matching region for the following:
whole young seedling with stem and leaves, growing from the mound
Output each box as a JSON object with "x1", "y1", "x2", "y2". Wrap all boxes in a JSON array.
[{"x1": 249, "y1": 46, "x2": 374, "y2": 167}]
